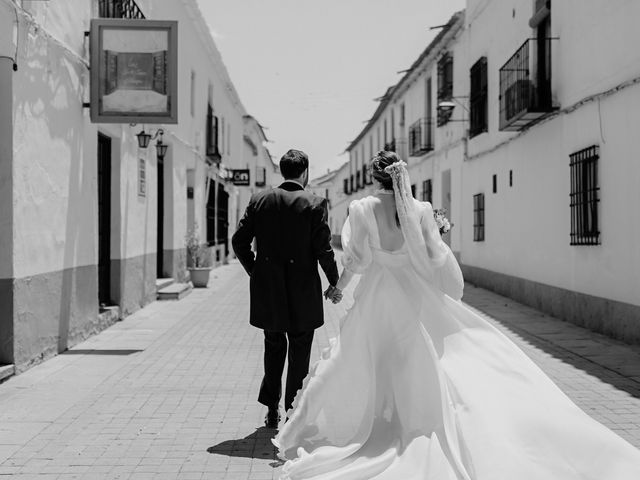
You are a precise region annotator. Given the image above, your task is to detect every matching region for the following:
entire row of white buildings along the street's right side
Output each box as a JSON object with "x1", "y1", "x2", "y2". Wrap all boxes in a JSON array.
[{"x1": 332, "y1": 0, "x2": 640, "y2": 343}]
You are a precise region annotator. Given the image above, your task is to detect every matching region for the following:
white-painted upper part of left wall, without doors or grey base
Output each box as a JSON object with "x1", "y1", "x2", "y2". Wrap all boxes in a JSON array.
[{"x1": 5, "y1": 0, "x2": 245, "y2": 277}]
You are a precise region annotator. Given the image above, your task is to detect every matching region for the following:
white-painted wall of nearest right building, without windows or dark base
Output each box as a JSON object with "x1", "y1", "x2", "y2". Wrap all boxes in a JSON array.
[{"x1": 462, "y1": 0, "x2": 640, "y2": 305}]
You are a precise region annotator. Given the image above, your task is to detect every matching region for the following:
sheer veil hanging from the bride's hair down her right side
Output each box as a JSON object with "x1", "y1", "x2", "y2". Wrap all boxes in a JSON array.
[{"x1": 384, "y1": 161, "x2": 464, "y2": 300}]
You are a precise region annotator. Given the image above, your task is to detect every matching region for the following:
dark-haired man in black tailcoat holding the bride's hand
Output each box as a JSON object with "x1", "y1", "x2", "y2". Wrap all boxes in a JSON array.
[{"x1": 232, "y1": 150, "x2": 342, "y2": 428}]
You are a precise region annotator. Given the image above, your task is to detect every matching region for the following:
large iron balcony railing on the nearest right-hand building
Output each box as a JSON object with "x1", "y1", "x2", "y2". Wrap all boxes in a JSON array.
[{"x1": 500, "y1": 38, "x2": 554, "y2": 131}]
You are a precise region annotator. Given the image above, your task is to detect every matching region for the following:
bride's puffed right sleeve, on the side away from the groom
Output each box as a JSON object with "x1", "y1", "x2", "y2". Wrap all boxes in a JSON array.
[{"x1": 420, "y1": 202, "x2": 464, "y2": 300}]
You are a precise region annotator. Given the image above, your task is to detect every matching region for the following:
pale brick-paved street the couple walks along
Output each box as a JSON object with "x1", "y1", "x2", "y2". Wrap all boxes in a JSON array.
[{"x1": 0, "y1": 263, "x2": 640, "y2": 480}]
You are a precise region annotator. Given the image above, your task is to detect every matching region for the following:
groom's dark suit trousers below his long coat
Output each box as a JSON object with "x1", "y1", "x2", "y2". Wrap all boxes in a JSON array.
[{"x1": 258, "y1": 330, "x2": 314, "y2": 410}]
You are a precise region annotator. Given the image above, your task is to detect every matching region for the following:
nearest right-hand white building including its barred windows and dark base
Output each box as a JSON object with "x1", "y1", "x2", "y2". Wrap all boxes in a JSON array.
[{"x1": 462, "y1": 0, "x2": 640, "y2": 343}]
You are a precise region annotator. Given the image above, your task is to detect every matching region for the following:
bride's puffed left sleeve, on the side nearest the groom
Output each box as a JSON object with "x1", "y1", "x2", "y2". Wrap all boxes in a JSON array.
[{"x1": 341, "y1": 201, "x2": 371, "y2": 274}]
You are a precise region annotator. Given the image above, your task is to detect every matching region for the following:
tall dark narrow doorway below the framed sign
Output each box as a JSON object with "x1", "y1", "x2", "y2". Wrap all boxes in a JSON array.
[{"x1": 98, "y1": 133, "x2": 111, "y2": 305}]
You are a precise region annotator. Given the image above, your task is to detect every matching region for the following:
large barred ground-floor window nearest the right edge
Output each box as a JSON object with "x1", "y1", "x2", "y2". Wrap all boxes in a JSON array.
[{"x1": 569, "y1": 145, "x2": 600, "y2": 245}]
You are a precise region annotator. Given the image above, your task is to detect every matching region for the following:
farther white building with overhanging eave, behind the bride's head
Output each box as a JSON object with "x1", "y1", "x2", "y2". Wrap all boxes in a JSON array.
[{"x1": 342, "y1": 12, "x2": 468, "y2": 255}]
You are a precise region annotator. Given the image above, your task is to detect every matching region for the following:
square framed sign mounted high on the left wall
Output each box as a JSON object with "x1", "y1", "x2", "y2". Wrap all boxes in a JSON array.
[{"x1": 91, "y1": 18, "x2": 178, "y2": 123}]
